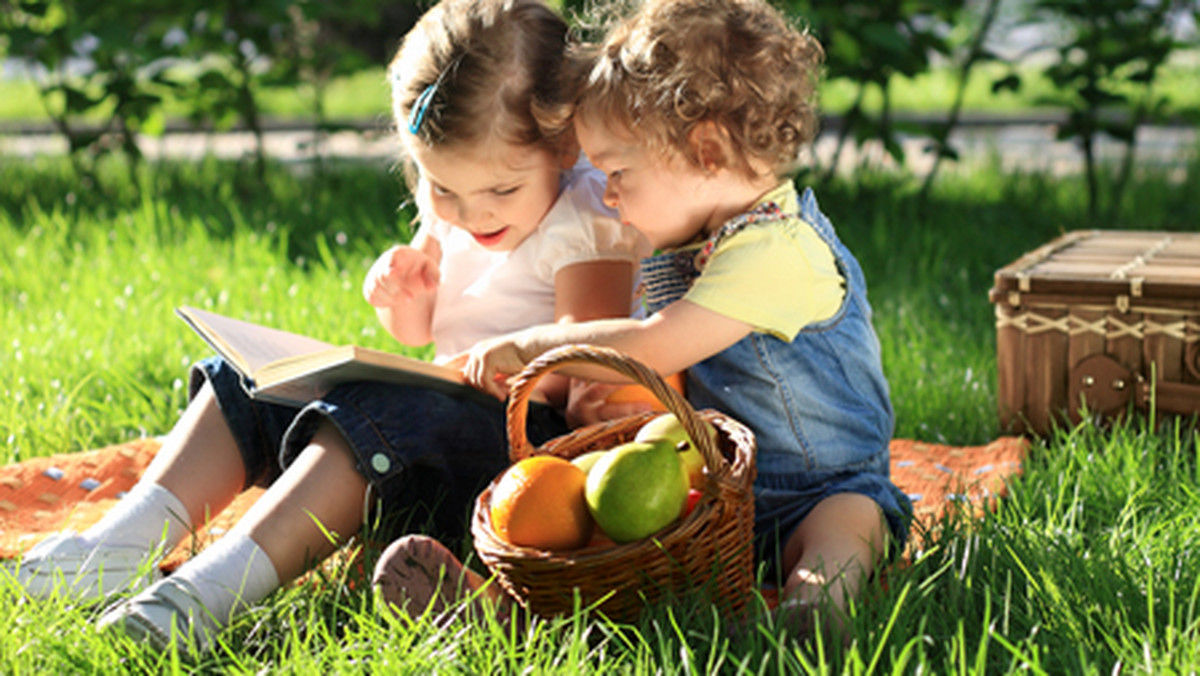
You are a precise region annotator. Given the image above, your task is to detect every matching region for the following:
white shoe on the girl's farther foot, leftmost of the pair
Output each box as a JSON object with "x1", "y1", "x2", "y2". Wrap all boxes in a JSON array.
[{"x1": 16, "y1": 531, "x2": 162, "y2": 600}]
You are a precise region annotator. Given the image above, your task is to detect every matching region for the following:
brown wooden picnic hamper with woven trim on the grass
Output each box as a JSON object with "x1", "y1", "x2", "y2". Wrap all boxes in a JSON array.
[{"x1": 989, "y1": 231, "x2": 1200, "y2": 435}]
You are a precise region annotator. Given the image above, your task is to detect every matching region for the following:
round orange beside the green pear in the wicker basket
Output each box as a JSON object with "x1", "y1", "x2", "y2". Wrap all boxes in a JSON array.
[{"x1": 490, "y1": 455, "x2": 594, "y2": 550}]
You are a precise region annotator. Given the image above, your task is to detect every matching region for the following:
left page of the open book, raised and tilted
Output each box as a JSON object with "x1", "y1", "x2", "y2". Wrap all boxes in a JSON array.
[{"x1": 176, "y1": 306, "x2": 334, "y2": 378}]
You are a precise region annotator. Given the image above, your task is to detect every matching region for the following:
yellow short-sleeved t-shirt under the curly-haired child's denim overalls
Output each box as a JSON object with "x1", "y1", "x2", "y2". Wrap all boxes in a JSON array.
[{"x1": 684, "y1": 181, "x2": 846, "y2": 341}]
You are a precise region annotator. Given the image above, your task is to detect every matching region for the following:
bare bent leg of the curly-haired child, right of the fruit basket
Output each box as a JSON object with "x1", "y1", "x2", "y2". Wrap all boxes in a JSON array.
[{"x1": 784, "y1": 493, "x2": 887, "y2": 620}]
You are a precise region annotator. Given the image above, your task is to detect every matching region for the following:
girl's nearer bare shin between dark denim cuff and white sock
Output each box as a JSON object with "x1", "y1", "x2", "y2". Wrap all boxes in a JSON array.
[{"x1": 233, "y1": 421, "x2": 367, "y2": 581}]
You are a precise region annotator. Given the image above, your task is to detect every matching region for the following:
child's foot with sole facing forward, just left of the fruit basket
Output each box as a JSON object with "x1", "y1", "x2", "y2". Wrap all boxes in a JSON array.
[{"x1": 372, "y1": 536, "x2": 512, "y2": 624}]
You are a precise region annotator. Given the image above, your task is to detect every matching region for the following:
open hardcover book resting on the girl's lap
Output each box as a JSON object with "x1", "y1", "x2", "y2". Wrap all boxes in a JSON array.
[{"x1": 175, "y1": 306, "x2": 492, "y2": 406}]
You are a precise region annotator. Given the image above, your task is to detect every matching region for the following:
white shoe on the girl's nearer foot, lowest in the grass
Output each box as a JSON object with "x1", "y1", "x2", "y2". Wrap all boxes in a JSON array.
[{"x1": 96, "y1": 576, "x2": 220, "y2": 654}]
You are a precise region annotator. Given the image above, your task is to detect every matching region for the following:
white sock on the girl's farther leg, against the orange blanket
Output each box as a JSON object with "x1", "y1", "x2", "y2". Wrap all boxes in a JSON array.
[{"x1": 80, "y1": 481, "x2": 191, "y2": 554}]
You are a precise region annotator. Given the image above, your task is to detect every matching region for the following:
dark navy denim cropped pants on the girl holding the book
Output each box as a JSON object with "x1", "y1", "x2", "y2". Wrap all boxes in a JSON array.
[{"x1": 190, "y1": 357, "x2": 568, "y2": 542}]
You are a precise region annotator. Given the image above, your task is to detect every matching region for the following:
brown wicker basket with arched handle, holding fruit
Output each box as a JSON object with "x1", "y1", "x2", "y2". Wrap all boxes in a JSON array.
[{"x1": 472, "y1": 345, "x2": 755, "y2": 621}]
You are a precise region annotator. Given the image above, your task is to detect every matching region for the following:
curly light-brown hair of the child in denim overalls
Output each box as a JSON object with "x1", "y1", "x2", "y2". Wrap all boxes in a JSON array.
[{"x1": 574, "y1": 0, "x2": 824, "y2": 177}]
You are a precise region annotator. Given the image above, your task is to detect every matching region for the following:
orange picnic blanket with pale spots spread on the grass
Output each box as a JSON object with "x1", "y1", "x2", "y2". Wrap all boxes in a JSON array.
[{"x1": 0, "y1": 437, "x2": 1028, "y2": 570}]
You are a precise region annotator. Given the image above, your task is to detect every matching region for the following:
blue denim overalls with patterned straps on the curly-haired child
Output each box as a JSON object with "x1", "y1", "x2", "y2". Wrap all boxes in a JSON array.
[{"x1": 642, "y1": 184, "x2": 912, "y2": 566}]
